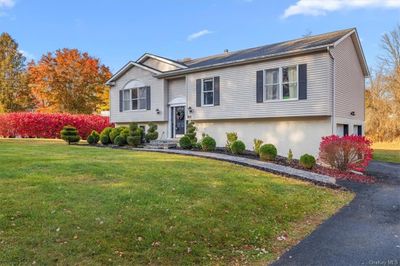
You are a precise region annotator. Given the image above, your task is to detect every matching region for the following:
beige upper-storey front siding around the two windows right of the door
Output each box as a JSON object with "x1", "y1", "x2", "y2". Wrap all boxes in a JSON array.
[{"x1": 187, "y1": 52, "x2": 332, "y2": 120}]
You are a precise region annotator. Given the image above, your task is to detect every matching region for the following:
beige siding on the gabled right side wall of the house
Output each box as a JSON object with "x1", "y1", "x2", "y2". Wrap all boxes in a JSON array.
[{"x1": 332, "y1": 36, "x2": 365, "y2": 121}]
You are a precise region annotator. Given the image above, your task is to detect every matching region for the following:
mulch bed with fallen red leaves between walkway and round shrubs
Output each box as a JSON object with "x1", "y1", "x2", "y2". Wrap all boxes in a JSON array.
[{"x1": 175, "y1": 148, "x2": 375, "y2": 183}]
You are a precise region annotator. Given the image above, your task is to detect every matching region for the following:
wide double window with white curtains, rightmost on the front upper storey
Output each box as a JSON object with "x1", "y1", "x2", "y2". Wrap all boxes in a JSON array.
[{"x1": 264, "y1": 66, "x2": 298, "y2": 101}]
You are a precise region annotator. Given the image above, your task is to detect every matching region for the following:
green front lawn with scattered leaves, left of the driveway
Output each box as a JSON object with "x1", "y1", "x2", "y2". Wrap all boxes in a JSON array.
[{"x1": 0, "y1": 139, "x2": 353, "y2": 265}]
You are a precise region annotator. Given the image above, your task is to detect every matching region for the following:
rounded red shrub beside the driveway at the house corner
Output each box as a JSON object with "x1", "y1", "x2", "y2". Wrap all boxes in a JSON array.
[{"x1": 319, "y1": 135, "x2": 372, "y2": 171}]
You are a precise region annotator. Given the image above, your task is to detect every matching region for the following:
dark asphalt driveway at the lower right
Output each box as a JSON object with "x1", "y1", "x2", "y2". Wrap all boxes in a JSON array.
[{"x1": 273, "y1": 161, "x2": 400, "y2": 265}]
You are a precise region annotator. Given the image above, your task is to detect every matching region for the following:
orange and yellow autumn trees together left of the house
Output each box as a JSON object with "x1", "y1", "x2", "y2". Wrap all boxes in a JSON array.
[{"x1": 0, "y1": 32, "x2": 111, "y2": 114}]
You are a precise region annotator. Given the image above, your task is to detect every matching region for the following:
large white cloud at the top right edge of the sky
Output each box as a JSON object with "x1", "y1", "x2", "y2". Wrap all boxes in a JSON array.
[{"x1": 282, "y1": 0, "x2": 400, "y2": 18}]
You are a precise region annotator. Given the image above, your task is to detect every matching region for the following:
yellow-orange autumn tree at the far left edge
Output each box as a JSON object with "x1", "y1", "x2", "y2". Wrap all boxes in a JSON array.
[{"x1": 0, "y1": 33, "x2": 32, "y2": 112}]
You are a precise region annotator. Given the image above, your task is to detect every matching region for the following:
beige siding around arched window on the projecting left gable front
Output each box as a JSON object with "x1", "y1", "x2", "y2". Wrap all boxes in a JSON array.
[{"x1": 110, "y1": 67, "x2": 167, "y2": 123}]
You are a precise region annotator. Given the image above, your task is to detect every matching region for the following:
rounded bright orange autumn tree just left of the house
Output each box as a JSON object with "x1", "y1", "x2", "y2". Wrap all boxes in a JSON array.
[{"x1": 28, "y1": 49, "x2": 111, "y2": 114}]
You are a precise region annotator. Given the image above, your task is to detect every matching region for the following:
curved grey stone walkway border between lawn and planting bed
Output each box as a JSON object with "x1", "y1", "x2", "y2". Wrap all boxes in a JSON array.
[{"x1": 92, "y1": 145, "x2": 342, "y2": 188}]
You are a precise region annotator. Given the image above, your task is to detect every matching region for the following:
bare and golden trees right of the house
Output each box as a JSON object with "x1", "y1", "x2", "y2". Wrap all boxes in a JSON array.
[{"x1": 366, "y1": 24, "x2": 400, "y2": 141}]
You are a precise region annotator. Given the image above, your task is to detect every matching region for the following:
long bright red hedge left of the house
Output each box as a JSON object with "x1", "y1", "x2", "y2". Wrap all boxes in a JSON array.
[{"x1": 0, "y1": 113, "x2": 110, "y2": 139}]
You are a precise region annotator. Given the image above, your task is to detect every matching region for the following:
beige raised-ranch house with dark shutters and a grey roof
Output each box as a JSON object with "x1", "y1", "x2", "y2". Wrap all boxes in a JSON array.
[{"x1": 107, "y1": 28, "x2": 369, "y2": 157}]
